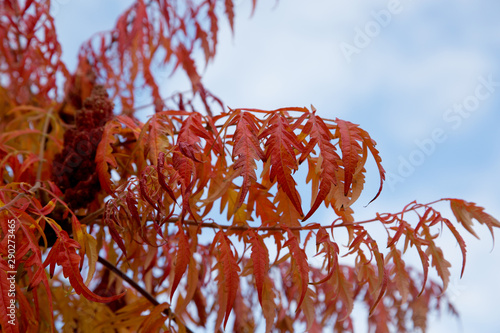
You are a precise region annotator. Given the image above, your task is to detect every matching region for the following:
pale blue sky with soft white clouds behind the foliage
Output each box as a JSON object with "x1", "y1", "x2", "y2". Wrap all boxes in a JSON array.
[{"x1": 52, "y1": 0, "x2": 500, "y2": 333}]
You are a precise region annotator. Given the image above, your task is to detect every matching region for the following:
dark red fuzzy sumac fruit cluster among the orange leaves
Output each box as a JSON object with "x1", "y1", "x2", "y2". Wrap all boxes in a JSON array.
[{"x1": 52, "y1": 86, "x2": 113, "y2": 209}]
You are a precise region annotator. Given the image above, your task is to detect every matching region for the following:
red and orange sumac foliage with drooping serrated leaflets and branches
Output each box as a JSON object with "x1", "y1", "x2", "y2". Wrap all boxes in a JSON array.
[{"x1": 0, "y1": 0, "x2": 500, "y2": 332}]
